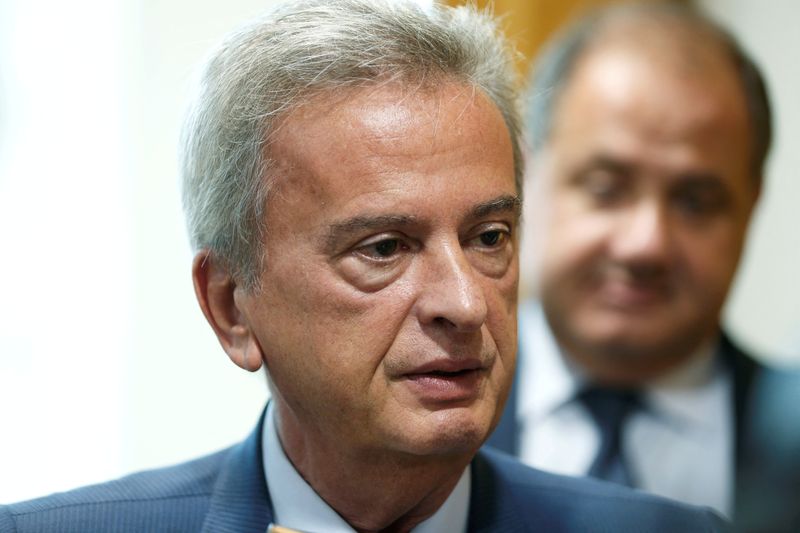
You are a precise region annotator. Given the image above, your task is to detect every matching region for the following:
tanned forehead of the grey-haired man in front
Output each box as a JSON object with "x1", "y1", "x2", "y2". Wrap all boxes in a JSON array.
[{"x1": 267, "y1": 82, "x2": 513, "y2": 186}]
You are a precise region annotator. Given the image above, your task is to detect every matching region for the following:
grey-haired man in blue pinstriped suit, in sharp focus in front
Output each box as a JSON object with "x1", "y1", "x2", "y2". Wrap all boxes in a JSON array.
[{"x1": 0, "y1": 0, "x2": 719, "y2": 532}]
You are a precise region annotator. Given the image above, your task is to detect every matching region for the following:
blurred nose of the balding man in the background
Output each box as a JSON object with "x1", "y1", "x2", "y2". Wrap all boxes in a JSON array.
[{"x1": 611, "y1": 200, "x2": 672, "y2": 263}]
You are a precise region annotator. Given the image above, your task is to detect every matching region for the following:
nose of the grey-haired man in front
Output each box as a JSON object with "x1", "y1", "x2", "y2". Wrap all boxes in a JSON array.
[{"x1": 417, "y1": 243, "x2": 487, "y2": 332}]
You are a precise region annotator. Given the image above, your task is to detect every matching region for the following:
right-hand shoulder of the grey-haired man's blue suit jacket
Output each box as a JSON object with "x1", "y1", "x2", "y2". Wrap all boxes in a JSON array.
[{"x1": 474, "y1": 448, "x2": 727, "y2": 533}]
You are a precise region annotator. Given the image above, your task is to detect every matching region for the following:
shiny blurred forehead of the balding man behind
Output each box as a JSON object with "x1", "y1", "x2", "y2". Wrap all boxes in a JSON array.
[{"x1": 554, "y1": 47, "x2": 749, "y2": 150}]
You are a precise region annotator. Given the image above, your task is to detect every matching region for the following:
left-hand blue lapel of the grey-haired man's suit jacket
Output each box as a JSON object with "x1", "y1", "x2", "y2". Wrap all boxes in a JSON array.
[{"x1": 202, "y1": 410, "x2": 272, "y2": 533}]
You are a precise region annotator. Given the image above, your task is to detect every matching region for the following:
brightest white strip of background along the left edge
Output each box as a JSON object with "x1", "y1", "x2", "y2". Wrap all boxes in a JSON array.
[{"x1": 0, "y1": 0, "x2": 133, "y2": 501}]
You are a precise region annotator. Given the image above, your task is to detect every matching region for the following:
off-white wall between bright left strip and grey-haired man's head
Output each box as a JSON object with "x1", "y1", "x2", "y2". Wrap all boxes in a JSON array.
[{"x1": 121, "y1": 0, "x2": 275, "y2": 478}]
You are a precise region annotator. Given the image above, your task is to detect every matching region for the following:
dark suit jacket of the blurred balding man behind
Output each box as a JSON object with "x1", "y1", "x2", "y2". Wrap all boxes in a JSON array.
[{"x1": 487, "y1": 334, "x2": 800, "y2": 533}]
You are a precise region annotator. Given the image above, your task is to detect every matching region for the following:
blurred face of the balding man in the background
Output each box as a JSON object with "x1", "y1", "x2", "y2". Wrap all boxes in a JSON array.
[{"x1": 533, "y1": 47, "x2": 758, "y2": 379}]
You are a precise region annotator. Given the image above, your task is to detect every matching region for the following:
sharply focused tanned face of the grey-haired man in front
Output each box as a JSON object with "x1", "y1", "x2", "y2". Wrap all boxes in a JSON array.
[{"x1": 238, "y1": 84, "x2": 518, "y2": 455}]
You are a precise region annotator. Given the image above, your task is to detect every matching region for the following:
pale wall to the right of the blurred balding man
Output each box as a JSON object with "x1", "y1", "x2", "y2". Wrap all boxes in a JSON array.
[{"x1": 700, "y1": 0, "x2": 800, "y2": 365}]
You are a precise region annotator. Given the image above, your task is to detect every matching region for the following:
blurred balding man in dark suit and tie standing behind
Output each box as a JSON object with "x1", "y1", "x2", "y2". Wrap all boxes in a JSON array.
[{"x1": 490, "y1": 4, "x2": 800, "y2": 531}]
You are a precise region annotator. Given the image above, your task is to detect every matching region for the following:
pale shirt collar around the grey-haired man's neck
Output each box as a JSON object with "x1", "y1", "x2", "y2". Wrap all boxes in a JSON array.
[{"x1": 262, "y1": 402, "x2": 470, "y2": 533}]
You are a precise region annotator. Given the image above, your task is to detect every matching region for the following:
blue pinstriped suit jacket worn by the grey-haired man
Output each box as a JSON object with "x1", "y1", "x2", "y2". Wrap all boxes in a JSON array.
[{"x1": 0, "y1": 408, "x2": 724, "y2": 533}]
